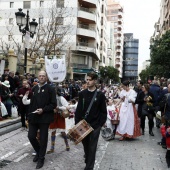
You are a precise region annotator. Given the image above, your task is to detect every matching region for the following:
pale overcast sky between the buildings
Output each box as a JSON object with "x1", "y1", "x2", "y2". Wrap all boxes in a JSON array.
[{"x1": 119, "y1": 0, "x2": 161, "y2": 72}]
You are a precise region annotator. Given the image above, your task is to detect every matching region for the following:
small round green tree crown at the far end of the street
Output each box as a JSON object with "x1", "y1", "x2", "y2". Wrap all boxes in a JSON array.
[{"x1": 99, "y1": 66, "x2": 120, "y2": 83}]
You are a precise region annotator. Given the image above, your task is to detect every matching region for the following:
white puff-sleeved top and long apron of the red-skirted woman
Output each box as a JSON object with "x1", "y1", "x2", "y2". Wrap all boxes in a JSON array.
[{"x1": 117, "y1": 89, "x2": 137, "y2": 135}]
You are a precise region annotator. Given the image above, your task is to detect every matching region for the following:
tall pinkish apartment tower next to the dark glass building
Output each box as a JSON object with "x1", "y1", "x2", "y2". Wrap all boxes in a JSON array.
[{"x1": 107, "y1": 0, "x2": 123, "y2": 78}]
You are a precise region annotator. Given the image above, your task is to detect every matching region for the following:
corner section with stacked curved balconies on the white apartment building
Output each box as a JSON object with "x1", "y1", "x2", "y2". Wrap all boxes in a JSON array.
[{"x1": 71, "y1": 0, "x2": 101, "y2": 79}]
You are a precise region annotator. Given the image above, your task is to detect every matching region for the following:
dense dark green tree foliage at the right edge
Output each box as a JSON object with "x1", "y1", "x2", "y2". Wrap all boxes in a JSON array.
[{"x1": 139, "y1": 31, "x2": 170, "y2": 82}]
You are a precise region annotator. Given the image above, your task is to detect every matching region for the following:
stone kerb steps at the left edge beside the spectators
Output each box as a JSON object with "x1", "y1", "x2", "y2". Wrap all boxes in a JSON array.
[{"x1": 0, "y1": 117, "x2": 21, "y2": 136}]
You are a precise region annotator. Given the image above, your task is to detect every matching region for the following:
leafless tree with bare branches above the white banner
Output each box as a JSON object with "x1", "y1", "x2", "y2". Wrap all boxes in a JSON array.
[{"x1": 28, "y1": 1, "x2": 72, "y2": 56}]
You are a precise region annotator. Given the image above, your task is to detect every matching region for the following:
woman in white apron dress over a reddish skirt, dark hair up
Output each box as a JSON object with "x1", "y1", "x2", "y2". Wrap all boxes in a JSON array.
[{"x1": 116, "y1": 81, "x2": 141, "y2": 141}]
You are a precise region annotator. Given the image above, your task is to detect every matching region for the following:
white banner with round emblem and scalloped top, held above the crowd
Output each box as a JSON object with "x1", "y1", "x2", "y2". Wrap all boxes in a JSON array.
[{"x1": 45, "y1": 55, "x2": 66, "y2": 83}]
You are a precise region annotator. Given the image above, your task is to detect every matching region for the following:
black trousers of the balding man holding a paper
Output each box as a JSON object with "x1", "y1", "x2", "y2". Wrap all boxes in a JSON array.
[{"x1": 28, "y1": 123, "x2": 49, "y2": 160}]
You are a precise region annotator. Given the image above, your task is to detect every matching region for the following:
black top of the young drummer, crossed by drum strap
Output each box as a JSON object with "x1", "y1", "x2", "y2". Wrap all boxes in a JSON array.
[{"x1": 75, "y1": 89, "x2": 107, "y2": 129}]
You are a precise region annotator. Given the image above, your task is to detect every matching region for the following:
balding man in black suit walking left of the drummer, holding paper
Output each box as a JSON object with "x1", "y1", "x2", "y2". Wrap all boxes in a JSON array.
[{"x1": 28, "y1": 71, "x2": 57, "y2": 169}]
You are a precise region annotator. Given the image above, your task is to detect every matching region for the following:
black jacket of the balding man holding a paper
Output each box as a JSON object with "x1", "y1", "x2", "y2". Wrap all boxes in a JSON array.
[{"x1": 28, "y1": 84, "x2": 57, "y2": 123}]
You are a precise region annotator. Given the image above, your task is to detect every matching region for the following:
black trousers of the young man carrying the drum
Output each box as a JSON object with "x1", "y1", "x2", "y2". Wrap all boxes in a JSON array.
[{"x1": 82, "y1": 127, "x2": 101, "y2": 170}]
